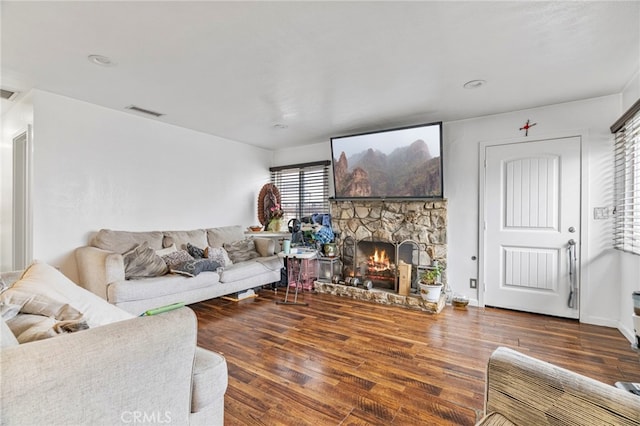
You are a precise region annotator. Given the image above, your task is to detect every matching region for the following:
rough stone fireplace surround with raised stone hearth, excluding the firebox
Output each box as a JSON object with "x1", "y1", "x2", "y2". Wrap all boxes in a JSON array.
[{"x1": 316, "y1": 199, "x2": 447, "y2": 311}]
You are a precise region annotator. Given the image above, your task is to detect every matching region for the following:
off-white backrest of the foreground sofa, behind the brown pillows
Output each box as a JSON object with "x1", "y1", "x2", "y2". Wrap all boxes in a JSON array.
[{"x1": 0, "y1": 261, "x2": 133, "y2": 327}]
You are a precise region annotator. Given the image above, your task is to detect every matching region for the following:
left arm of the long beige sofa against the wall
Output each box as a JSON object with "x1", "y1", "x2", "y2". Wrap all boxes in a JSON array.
[{"x1": 76, "y1": 246, "x2": 124, "y2": 301}]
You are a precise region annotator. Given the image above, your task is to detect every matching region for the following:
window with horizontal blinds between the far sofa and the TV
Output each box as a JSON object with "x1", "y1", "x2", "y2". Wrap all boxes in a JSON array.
[{"x1": 269, "y1": 161, "x2": 331, "y2": 222}]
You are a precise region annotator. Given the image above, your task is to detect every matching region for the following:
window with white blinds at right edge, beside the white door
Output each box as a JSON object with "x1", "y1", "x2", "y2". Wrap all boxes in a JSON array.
[{"x1": 611, "y1": 100, "x2": 640, "y2": 255}]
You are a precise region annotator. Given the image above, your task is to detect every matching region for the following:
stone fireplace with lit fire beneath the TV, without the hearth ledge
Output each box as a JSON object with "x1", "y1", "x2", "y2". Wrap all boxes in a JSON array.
[{"x1": 331, "y1": 200, "x2": 447, "y2": 293}]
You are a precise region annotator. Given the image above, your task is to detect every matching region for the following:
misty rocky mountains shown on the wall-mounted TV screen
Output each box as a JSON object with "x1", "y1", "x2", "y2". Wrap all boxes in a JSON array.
[{"x1": 333, "y1": 139, "x2": 442, "y2": 198}]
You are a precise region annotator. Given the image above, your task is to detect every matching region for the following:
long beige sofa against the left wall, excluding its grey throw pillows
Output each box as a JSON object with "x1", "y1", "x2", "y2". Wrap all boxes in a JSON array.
[{"x1": 76, "y1": 226, "x2": 283, "y2": 315}]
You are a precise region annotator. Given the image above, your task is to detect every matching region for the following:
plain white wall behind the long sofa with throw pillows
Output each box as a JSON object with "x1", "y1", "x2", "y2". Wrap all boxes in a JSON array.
[{"x1": 8, "y1": 91, "x2": 272, "y2": 279}]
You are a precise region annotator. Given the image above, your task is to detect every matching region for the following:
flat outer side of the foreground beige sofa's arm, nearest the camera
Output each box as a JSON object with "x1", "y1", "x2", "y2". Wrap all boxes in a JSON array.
[{"x1": 0, "y1": 308, "x2": 197, "y2": 425}]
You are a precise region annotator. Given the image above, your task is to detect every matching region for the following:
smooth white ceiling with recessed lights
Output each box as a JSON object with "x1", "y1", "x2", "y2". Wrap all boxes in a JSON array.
[{"x1": 0, "y1": 1, "x2": 640, "y2": 149}]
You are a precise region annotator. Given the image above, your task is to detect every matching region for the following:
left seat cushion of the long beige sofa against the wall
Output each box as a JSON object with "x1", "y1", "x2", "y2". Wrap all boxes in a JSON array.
[{"x1": 107, "y1": 272, "x2": 220, "y2": 303}]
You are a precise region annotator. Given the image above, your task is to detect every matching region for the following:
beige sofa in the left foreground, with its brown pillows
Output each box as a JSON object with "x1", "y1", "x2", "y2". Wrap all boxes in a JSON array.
[{"x1": 0, "y1": 262, "x2": 228, "y2": 426}]
